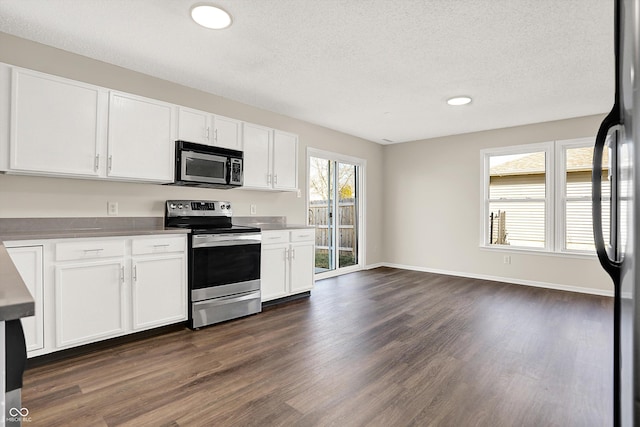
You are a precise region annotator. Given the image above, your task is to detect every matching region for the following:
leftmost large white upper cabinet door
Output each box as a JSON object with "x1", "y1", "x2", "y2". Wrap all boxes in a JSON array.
[{"x1": 9, "y1": 69, "x2": 107, "y2": 176}]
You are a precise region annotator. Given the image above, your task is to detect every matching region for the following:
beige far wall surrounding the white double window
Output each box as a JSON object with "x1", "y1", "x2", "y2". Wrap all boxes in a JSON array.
[{"x1": 383, "y1": 115, "x2": 613, "y2": 294}]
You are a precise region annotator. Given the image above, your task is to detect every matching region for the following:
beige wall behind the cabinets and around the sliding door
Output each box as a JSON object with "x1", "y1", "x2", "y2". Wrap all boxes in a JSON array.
[{"x1": 0, "y1": 32, "x2": 383, "y2": 264}]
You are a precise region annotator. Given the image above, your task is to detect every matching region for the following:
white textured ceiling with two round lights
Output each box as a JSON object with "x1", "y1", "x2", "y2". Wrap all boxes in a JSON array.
[{"x1": 0, "y1": 0, "x2": 614, "y2": 143}]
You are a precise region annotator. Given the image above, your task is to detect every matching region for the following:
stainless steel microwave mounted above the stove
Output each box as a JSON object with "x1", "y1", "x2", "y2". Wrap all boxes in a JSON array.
[{"x1": 173, "y1": 141, "x2": 243, "y2": 188}]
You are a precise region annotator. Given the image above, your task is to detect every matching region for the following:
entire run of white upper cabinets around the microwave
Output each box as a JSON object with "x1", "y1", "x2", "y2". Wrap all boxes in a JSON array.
[{"x1": 0, "y1": 64, "x2": 298, "y2": 186}]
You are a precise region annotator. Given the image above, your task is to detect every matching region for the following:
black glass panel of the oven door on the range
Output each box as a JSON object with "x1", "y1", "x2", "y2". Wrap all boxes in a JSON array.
[{"x1": 191, "y1": 244, "x2": 260, "y2": 289}]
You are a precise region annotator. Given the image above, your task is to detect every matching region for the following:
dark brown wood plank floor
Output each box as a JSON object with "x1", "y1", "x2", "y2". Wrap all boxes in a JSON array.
[{"x1": 23, "y1": 268, "x2": 612, "y2": 427}]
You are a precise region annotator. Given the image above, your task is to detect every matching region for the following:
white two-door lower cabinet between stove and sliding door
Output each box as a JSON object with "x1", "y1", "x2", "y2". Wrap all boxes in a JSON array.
[{"x1": 260, "y1": 229, "x2": 315, "y2": 302}]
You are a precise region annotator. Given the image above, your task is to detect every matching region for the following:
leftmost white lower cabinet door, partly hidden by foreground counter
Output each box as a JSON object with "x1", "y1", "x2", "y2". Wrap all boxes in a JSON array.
[{"x1": 7, "y1": 246, "x2": 44, "y2": 351}]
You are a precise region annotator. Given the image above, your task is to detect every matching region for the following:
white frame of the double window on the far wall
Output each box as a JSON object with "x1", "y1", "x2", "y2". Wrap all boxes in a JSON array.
[{"x1": 480, "y1": 137, "x2": 596, "y2": 257}]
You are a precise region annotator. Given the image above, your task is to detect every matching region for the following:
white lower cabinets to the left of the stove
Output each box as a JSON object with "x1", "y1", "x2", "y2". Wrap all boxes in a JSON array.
[{"x1": 5, "y1": 234, "x2": 187, "y2": 357}]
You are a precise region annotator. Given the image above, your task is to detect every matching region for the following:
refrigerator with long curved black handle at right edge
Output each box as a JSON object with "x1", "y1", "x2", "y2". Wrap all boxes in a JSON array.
[{"x1": 592, "y1": 0, "x2": 640, "y2": 426}]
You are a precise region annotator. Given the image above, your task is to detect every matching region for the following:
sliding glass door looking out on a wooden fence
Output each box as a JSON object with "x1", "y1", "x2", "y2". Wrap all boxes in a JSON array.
[{"x1": 308, "y1": 149, "x2": 361, "y2": 275}]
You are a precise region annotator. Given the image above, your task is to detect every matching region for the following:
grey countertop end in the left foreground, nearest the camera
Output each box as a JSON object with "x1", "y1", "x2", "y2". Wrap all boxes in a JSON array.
[{"x1": 0, "y1": 244, "x2": 35, "y2": 321}]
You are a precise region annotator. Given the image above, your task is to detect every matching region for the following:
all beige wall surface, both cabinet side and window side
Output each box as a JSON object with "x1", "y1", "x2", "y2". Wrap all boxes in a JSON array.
[{"x1": 0, "y1": 33, "x2": 612, "y2": 292}]
